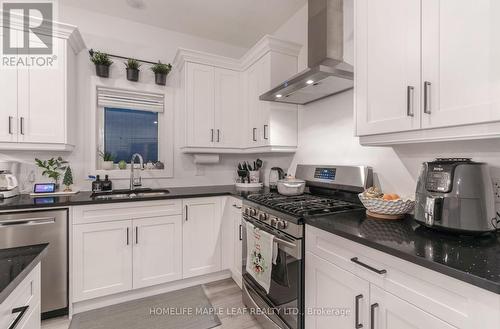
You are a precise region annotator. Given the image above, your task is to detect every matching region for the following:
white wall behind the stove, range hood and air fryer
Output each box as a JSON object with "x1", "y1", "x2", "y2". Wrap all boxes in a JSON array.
[{"x1": 274, "y1": 0, "x2": 500, "y2": 195}]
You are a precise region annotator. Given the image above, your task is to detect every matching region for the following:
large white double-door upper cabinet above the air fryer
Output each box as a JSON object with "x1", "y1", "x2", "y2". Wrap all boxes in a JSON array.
[{"x1": 355, "y1": 0, "x2": 500, "y2": 145}]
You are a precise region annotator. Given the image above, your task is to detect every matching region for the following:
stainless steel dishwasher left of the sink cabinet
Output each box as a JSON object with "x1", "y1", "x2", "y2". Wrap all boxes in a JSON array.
[{"x1": 0, "y1": 210, "x2": 68, "y2": 318}]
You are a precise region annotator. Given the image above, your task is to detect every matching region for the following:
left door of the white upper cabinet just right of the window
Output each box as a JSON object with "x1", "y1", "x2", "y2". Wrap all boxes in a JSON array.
[{"x1": 186, "y1": 63, "x2": 215, "y2": 147}]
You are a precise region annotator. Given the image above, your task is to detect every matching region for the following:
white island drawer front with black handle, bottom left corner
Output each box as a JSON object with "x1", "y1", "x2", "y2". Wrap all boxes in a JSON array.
[{"x1": 0, "y1": 264, "x2": 40, "y2": 329}]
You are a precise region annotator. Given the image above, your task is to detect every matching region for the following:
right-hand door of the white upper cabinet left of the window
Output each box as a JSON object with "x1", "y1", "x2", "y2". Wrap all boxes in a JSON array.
[{"x1": 18, "y1": 38, "x2": 67, "y2": 143}]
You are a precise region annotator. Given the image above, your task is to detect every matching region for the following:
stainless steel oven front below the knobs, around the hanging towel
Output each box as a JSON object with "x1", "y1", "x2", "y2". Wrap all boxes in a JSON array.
[{"x1": 242, "y1": 214, "x2": 304, "y2": 329}]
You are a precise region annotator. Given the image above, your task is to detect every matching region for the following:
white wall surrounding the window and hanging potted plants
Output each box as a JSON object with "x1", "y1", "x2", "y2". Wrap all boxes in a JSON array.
[{"x1": 0, "y1": 6, "x2": 291, "y2": 190}]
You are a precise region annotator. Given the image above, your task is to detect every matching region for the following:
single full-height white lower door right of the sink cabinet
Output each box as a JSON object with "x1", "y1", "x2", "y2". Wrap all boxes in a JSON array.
[{"x1": 182, "y1": 198, "x2": 222, "y2": 278}]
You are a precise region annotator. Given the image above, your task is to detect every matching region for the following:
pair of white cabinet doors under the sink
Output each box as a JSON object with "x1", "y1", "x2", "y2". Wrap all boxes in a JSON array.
[{"x1": 73, "y1": 209, "x2": 182, "y2": 302}]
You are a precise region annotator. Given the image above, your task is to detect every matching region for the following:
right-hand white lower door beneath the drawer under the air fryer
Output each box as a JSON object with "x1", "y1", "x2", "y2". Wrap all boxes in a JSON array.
[{"x1": 370, "y1": 285, "x2": 456, "y2": 329}]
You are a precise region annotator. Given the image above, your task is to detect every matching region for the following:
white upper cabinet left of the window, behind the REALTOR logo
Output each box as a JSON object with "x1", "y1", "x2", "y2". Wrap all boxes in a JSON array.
[{"x1": 0, "y1": 22, "x2": 85, "y2": 151}]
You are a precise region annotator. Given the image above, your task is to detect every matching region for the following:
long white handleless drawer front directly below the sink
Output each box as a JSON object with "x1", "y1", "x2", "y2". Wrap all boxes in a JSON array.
[{"x1": 72, "y1": 199, "x2": 182, "y2": 224}]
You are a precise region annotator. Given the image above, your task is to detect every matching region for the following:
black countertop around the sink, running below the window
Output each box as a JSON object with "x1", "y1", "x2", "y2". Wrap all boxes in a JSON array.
[{"x1": 0, "y1": 185, "x2": 259, "y2": 211}]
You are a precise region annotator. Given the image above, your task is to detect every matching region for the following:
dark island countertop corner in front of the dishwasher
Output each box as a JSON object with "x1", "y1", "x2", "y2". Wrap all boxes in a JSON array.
[{"x1": 0, "y1": 243, "x2": 49, "y2": 304}]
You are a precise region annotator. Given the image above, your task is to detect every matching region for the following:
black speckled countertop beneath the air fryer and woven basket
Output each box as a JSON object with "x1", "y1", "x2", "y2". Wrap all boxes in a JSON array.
[{"x1": 306, "y1": 212, "x2": 500, "y2": 294}]
